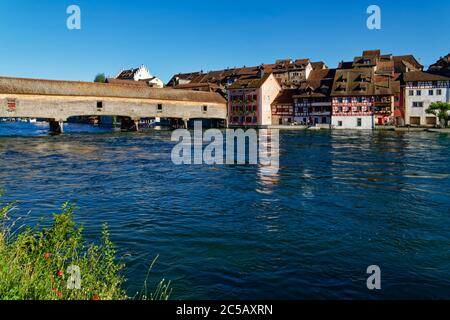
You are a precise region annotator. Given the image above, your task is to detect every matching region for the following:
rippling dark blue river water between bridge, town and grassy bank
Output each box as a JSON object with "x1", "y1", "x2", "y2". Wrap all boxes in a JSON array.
[{"x1": 0, "y1": 124, "x2": 450, "y2": 299}]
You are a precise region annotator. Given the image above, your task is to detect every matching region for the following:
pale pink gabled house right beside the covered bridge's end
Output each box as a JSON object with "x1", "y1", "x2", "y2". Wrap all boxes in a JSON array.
[{"x1": 228, "y1": 73, "x2": 281, "y2": 126}]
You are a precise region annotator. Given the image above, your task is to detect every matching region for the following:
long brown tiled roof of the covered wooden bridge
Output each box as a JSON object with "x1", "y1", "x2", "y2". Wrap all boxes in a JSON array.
[{"x1": 0, "y1": 77, "x2": 226, "y2": 104}]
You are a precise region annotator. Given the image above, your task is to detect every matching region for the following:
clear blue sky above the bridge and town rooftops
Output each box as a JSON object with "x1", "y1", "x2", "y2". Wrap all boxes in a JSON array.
[{"x1": 0, "y1": 0, "x2": 450, "y2": 81}]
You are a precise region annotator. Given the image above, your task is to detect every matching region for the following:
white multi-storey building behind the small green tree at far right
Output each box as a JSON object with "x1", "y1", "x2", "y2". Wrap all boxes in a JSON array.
[{"x1": 404, "y1": 71, "x2": 450, "y2": 126}]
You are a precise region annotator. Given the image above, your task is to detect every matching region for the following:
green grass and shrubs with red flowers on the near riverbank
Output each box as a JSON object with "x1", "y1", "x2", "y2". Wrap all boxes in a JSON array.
[{"x1": 0, "y1": 195, "x2": 171, "y2": 300}]
